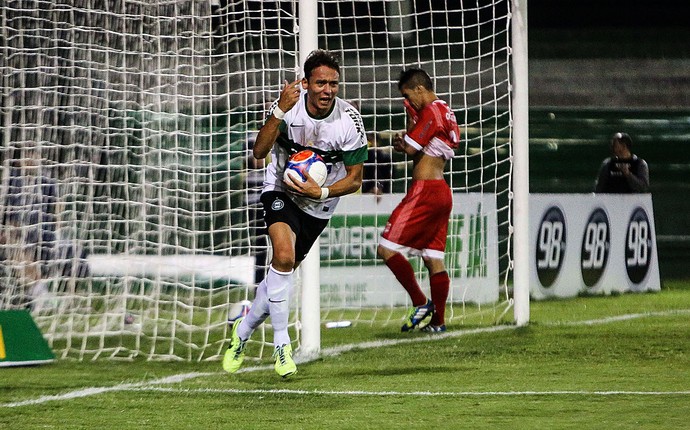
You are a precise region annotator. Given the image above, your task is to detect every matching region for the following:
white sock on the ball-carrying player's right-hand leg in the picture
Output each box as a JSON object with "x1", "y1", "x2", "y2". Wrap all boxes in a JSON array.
[{"x1": 266, "y1": 266, "x2": 294, "y2": 346}]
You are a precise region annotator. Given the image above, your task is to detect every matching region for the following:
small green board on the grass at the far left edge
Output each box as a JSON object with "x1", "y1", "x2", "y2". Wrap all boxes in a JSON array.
[{"x1": 0, "y1": 311, "x2": 55, "y2": 367}]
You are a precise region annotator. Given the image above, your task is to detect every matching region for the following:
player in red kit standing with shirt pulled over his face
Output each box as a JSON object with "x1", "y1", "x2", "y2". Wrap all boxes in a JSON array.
[{"x1": 377, "y1": 69, "x2": 460, "y2": 333}]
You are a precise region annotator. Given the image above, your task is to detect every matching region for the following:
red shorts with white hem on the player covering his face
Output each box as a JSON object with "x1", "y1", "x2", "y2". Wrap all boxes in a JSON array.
[{"x1": 381, "y1": 179, "x2": 453, "y2": 258}]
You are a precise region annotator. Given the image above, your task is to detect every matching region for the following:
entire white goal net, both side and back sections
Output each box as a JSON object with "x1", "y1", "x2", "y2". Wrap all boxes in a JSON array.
[{"x1": 0, "y1": 0, "x2": 511, "y2": 360}]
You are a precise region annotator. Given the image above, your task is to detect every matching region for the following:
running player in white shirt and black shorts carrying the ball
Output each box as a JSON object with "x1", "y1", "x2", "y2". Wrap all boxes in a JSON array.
[{"x1": 223, "y1": 50, "x2": 367, "y2": 377}]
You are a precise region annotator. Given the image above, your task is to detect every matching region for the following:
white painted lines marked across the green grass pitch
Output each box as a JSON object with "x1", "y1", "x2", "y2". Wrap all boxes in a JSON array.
[{"x1": 0, "y1": 309, "x2": 690, "y2": 408}]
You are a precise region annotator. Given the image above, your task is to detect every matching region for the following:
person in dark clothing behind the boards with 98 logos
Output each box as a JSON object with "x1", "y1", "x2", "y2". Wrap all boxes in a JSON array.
[{"x1": 594, "y1": 133, "x2": 649, "y2": 193}]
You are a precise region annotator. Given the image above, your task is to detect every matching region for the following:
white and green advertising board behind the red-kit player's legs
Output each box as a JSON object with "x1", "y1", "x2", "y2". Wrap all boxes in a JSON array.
[{"x1": 319, "y1": 193, "x2": 499, "y2": 307}]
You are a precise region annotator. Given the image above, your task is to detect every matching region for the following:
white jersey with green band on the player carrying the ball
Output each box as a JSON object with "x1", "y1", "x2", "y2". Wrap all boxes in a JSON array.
[{"x1": 263, "y1": 91, "x2": 367, "y2": 219}]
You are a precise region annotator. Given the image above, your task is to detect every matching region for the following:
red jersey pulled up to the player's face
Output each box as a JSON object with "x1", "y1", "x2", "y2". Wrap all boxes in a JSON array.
[{"x1": 405, "y1": 100, "x2": 460, "y2": 159}]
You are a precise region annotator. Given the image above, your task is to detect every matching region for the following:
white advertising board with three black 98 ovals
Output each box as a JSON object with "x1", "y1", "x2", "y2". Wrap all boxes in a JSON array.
[{"x1": 530, "y1": 194, "x2": 661, "y2": 299}]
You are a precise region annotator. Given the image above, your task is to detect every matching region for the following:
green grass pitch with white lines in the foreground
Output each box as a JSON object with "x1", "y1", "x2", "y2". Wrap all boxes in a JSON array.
[{"x1": 0, "y1": 282, "x2": 690, "y2": 430}]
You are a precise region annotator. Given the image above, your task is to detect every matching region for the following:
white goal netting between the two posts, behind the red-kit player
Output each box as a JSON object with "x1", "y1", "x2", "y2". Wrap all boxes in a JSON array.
[{"x1": 319, "y1": 0, "x2": 511, "y2": 324}]
